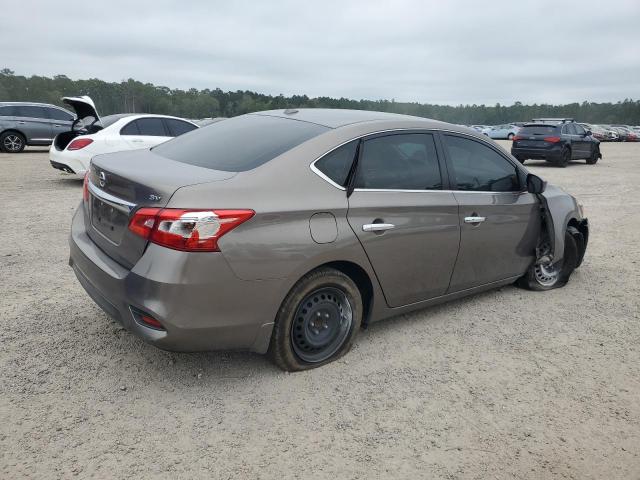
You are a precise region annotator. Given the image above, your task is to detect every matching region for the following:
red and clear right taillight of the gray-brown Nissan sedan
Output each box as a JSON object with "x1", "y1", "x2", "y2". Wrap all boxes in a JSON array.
[{"x1": 129, "y1": 208, "x2": 255, "y2": 252}]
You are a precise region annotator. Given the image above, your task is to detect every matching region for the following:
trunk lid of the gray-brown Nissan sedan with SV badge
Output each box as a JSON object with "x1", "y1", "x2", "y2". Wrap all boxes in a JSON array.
[{"x1": 84, "y1": 150, "x2": 235, "y2": 268}]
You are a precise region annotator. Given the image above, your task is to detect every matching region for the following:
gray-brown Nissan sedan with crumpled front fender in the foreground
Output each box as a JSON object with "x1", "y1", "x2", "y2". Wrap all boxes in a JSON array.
[{"x1": 70, "y1": 109, "x2": 588, "y2": 370}]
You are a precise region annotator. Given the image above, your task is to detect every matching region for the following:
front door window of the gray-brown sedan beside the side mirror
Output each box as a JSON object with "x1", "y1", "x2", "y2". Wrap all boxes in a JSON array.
[{"x1": 444, "y1": 135, "x2": 520, "y2": 192}]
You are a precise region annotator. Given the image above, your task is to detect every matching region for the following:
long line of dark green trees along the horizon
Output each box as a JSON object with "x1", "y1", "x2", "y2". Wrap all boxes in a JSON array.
[{"x1": 0, "y1": 68, "x2": 640, "y2": 125}]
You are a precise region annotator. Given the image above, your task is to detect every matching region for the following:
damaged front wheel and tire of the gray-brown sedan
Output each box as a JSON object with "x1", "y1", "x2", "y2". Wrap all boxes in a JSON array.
[{"x1": 516, "y1": 230, "x2": 580, "y2": 292}]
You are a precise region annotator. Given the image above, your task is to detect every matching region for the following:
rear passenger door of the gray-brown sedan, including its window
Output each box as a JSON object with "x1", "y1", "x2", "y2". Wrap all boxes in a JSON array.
[{"x1": 347, "y1": 132, "x2": 460, "y2": 307}]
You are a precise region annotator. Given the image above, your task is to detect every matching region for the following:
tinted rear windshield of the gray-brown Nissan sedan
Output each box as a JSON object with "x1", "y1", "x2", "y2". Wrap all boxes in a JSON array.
[{"x1": 153, "y1": 115, "x2": 329, "y2": 172}]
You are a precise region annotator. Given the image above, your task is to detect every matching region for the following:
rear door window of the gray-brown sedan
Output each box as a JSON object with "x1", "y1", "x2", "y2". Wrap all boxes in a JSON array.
[{"x1": 355, "y1": 133, "x2": 442, "y2": 190}]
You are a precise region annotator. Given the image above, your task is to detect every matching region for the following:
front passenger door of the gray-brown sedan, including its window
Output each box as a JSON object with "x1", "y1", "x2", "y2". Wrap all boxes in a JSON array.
[{"x1": 442, "y1": 133, "x2": 540, "y2": 292}]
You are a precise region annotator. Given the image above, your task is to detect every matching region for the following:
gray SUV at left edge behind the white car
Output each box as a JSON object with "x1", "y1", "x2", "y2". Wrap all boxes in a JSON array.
[{"x1": 0, "y1": 102, "x2": 75, "y2": 153}]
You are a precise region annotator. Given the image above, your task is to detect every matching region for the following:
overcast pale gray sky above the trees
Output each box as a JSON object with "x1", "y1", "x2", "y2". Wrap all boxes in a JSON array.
[{"x1": 5, "y1": 0, "x2": 640, "y2": 105}]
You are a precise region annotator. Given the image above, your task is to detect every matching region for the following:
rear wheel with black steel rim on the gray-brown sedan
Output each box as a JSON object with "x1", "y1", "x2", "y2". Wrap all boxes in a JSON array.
[{"x1": 268, "y1": 268, "x2": 363, "y2": 372}]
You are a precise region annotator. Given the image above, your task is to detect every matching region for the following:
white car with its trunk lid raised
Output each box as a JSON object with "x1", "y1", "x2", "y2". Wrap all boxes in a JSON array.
[{"x1": 49, "y1": 96, "x2": 198, "y2": 175}]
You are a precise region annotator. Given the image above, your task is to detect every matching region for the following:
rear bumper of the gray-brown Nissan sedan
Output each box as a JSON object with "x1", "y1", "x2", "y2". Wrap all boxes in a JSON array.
[{"x1": 69, "y1": 206, "x2": 285, "y2": 353}]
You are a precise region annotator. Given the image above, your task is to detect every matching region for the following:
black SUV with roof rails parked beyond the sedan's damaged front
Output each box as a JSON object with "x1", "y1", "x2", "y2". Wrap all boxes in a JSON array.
[{"x1": 511, "y1": 119, "x2": 602, "y2": 167}]
